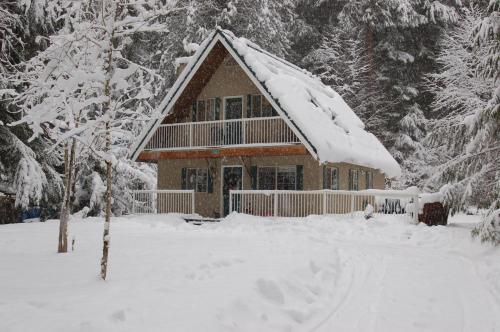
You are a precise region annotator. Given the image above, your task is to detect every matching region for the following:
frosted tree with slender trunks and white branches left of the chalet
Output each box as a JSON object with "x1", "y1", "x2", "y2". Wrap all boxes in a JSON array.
[{"x1": 10, "y1": 0, "x2": 179, "y2": 268}]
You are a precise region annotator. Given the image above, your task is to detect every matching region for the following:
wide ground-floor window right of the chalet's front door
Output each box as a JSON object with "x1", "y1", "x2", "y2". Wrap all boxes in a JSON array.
[{"x1": 257, "y1": 166, "x2": 297, "y2": 190}]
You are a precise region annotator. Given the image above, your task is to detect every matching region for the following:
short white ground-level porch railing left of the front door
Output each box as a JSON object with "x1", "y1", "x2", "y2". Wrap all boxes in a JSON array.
[{"x1": 132, "y1": 190, "x2": 194, "y2": 214}]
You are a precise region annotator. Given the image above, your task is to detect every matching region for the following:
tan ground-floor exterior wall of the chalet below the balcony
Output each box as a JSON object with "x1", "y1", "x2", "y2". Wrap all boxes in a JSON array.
[{"x1": 158, "y1": 155, "x2": 385, "y2": 217}]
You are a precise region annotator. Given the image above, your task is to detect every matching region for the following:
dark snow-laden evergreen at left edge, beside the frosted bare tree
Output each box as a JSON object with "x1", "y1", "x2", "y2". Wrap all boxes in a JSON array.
[{"x1": 0, "y1": 1, "x2": 62, "y2": 211}]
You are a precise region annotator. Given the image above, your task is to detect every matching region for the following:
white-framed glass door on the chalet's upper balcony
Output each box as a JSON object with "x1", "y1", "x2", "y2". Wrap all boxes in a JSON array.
[{"x1": 224, "y1": 96, "x2": 243, "y2": 145}]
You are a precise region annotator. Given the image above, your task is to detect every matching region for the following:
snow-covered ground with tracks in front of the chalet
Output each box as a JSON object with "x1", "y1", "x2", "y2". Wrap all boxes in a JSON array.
[{"x1": 0, "y1": 215, "x2": 500, "y2": 332}]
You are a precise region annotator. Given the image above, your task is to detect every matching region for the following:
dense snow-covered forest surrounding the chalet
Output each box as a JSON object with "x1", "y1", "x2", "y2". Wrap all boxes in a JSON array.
[{"x1": 0, "y1": 0, "x2": 500, "y2": 239}]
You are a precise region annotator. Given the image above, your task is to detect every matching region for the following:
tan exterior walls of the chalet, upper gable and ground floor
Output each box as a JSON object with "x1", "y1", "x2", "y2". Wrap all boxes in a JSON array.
[{"x1": 158, "y1": 53, "x2": 385, "y2": 217}]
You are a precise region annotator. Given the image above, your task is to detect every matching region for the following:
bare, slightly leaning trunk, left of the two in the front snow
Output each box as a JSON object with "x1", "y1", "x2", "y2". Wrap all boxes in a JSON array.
[{"x1": 57, "y1": 139, "x2": 76, "y2": 253}]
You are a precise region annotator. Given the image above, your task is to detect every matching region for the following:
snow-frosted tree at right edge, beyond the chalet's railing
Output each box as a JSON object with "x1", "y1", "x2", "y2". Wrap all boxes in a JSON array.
[{"x1": 425, "y1": 4, "x2": 500, "y2": 241}]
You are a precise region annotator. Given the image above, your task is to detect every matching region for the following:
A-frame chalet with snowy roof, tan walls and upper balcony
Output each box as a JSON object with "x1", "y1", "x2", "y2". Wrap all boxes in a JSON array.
[{"x1": 131, "y1": 29, "x2": 400, "y2": 217}]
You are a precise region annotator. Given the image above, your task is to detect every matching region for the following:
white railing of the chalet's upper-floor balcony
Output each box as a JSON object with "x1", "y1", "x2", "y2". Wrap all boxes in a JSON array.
[{"x1": 146, "y1": 116, "x2": 300, "y2": 150}]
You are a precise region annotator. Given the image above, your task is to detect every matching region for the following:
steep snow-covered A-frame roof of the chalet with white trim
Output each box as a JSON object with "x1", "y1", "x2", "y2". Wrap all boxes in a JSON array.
[{"x1": 132, "y1": 29, "x2": 401, "y2": 177}]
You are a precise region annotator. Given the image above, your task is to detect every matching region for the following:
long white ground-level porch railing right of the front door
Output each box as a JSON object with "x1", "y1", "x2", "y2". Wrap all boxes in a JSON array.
[{"x1": 229, "y1": 189, "x2": 418, "y2": 222}]
